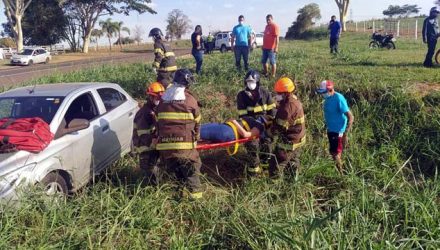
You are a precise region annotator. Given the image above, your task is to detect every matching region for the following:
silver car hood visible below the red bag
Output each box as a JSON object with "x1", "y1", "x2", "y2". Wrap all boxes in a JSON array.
[{"x1": 0, "y1": 151, "x2": 34, "y2": 176}]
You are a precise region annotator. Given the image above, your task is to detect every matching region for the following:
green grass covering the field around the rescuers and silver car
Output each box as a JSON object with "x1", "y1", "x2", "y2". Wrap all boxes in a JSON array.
[{"x1": 0, "y1": 33, "x2": 440, "y2": 249}]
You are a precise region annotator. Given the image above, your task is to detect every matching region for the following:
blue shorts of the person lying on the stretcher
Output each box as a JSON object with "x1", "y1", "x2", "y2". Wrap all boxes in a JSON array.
[{"x1": 200, "y1": 123, "x2": 235, "y2": 142}]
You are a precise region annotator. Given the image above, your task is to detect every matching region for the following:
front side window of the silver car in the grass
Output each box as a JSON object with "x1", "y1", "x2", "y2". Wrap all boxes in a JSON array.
[{"x1": 64, "y1": 92, "x2": 99, "y2": 125}]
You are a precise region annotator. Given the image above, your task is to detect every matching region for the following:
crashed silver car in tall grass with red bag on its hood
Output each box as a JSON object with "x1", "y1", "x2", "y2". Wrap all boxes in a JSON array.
[{"x1": 0, "y1": 83, "x2": 138, "y2": 201}]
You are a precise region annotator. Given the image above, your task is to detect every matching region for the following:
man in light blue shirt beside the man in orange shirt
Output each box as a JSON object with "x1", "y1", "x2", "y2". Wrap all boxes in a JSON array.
[{"x1": 231, "y1": 15, "x2": 252, "y2": 71}]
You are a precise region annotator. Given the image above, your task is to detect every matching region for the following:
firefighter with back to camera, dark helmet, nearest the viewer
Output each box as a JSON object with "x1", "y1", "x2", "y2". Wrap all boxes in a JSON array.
[{"x1": 156, "y1": 69, "x2": 203, "y2": 199}]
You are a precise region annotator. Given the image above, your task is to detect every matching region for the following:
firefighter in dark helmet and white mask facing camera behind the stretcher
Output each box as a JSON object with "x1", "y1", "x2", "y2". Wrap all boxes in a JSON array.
[{"x1": 237, "y1": 70, "x2": 276, "y2": 175}]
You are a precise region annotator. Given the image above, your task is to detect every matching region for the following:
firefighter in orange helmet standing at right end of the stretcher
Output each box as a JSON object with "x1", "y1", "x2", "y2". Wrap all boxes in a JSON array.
[{"x1": 269, "y1": 77, "x2": 306, "y2": 177}]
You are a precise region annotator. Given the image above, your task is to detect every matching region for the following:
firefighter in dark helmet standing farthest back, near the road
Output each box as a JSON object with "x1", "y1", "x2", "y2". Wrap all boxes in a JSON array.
[{"x1": 148, "y1": 28, "x2": 177, "y2": 88}]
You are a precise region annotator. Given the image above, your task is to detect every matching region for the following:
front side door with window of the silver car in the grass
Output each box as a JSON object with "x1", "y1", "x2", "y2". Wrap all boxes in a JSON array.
[{"x1": 59, "y1": 91, "x2": 100, "y2": 186}]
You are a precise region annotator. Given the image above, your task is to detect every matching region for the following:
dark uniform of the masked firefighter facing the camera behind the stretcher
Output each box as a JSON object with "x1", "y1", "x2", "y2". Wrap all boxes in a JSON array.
[{"x1": 237, "y1": 87, "x2": 276, "y2": 173}]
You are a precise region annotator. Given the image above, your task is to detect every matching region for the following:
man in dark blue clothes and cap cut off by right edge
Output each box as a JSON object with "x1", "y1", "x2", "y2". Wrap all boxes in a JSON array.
[{"x1": 422, "y1": 7, "x2": 440, "y2": 68}]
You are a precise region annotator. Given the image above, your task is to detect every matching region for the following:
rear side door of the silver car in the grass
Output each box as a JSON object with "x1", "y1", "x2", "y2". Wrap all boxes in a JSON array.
[{"x1": 97, "y1": 87, "x2": 136, "y2": 171}]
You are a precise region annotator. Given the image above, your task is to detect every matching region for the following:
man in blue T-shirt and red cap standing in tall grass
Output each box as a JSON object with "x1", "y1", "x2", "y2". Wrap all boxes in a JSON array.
[{"x1": 316, "y1": 80, "x2": 354, "y2": 174}]
